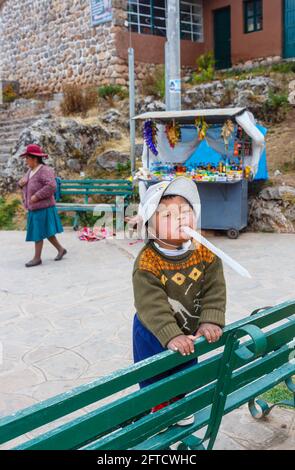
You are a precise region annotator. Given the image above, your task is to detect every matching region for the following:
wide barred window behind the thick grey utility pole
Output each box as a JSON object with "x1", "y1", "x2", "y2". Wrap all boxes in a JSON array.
[{"x1": 128, "y1": 0, "x2": 203, "y2": 42}]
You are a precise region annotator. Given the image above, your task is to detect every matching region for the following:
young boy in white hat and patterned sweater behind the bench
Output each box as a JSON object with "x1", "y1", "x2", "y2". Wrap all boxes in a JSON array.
[{"x1": 133, "y1": 177, "x2": 226, "y2": 426}]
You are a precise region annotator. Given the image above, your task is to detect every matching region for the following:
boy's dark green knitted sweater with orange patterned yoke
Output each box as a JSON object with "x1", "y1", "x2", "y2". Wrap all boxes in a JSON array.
[{"x1": 133, "y1": 241, "x2": 226, "y2": 347}]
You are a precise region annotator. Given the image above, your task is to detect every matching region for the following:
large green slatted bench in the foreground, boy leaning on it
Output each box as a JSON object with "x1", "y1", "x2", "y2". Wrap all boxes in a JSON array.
[{"x1": 0, "y1": 301, "x2": 295, "y2": 450}]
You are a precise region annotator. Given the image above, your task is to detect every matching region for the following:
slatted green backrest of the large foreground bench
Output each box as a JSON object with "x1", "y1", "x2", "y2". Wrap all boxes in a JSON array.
[{"x1": 0, "y1": 302, "x2": 295, "y2": 449}]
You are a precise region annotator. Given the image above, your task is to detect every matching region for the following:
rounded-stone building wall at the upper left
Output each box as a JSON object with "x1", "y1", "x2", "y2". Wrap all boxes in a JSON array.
[{"x1": 0, "y1": 0, "x2": 128, "y2": 92}]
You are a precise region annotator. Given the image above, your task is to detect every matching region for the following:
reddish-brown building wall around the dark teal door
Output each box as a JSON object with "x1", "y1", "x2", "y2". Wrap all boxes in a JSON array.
[{"x1": 204, "y1": 0, "x2": 283, "y2": 64}]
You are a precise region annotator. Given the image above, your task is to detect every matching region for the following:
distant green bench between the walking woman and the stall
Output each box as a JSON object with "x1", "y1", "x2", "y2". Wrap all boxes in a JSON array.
[{"x1": 55, "y1": 178, "x2": 133, "y2": 230}]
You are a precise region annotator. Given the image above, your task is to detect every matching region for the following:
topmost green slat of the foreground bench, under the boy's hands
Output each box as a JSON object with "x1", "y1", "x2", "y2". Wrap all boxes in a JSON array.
[{"x1": 0, "y1": 302, "x2": 295, "y2": 443}]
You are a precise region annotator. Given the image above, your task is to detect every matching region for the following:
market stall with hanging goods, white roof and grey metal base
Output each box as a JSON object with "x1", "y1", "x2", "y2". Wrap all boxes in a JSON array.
[{"x1": 134, "y1": 108, "x2": 268, "y2": 238}]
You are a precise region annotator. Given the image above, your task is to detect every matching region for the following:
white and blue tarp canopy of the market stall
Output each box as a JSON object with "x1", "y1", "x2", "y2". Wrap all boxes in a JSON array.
[{"x1": 133, "y1": 108, "x2": 268, "y2": 179}]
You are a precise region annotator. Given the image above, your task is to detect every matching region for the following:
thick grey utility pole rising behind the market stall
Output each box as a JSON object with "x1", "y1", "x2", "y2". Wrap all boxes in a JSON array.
[{"x1": 166, "y1": 0, "x2": 181, "y2": 111}]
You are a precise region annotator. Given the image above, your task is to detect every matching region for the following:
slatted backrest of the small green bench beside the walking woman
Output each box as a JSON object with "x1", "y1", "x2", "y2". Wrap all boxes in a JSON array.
[{"x1": 56, "y1": 178, "x2": 133, "y2": 203}]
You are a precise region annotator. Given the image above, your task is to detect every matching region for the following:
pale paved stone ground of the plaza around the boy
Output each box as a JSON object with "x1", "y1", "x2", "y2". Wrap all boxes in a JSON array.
[{"x1": 0, "y1": 230, "x2": 295, "y2": 449}]
